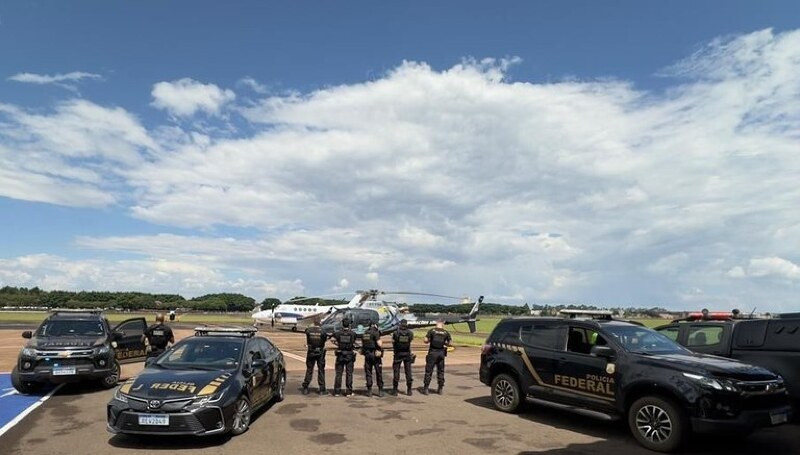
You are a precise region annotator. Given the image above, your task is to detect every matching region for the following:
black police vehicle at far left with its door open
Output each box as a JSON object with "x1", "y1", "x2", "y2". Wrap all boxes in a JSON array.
[{"x1": 11, "y1": 310, "x2": 147, "y2": 394}]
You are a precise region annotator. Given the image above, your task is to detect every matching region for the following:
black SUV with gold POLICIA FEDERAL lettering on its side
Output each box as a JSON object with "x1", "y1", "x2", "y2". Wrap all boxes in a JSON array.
[{"x1": 480, "y1": 318, "x2": 791, "y2": 452}]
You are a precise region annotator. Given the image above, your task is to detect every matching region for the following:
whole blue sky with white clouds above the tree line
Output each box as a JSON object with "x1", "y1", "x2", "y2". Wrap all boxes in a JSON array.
[{"x1": 0, "y1": 1, "x2": 800, "y2": 310}]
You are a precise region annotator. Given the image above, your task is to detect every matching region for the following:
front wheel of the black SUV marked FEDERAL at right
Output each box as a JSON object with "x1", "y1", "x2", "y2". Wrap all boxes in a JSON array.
[{"x1": 628, "y1": 396, "x2": 690, "y2": 452}]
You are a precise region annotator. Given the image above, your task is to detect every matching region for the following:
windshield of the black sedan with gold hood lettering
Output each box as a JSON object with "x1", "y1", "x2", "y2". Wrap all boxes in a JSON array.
[{"x1": 155, "y1": 337, "x2": 243, "y2": 370}]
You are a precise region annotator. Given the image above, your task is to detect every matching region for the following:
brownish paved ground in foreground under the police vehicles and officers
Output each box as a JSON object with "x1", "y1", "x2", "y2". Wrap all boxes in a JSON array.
[{"x1": 0, "y1": 332, "x2": 800, "y2": 455}]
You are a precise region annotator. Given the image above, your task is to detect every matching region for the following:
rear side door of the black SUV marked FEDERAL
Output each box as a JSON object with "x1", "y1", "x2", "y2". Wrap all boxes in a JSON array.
[{"x1": 517, "y1": 321, "x2": 564, "y2": 398}]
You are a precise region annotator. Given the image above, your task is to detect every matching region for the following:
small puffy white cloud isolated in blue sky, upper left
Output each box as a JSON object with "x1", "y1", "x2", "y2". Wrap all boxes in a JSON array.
[{"x1": 151, "y1": 78, "x2": 236, "y2": 117}]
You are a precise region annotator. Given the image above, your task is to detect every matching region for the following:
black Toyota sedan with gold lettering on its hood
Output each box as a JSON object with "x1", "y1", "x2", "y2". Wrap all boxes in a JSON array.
[{"x1": 107, "y1": 327, "x2": 286, "y2": 435}]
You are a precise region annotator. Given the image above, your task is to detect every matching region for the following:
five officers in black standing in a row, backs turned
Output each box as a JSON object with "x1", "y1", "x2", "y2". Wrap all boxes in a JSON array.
[{"x1": 303, "y1": 319, "x2": 452, "y2": 397}]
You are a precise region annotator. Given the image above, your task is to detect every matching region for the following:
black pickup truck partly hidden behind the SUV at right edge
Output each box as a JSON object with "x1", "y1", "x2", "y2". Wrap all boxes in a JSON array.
[{"x1": 656, "y1": 313, "x2": 800, "y2": 408}]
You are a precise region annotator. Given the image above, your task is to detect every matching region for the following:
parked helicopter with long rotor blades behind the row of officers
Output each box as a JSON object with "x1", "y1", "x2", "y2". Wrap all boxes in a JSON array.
[{"x1": 298, "y1": 289, "x2": 483, "y2": 336}]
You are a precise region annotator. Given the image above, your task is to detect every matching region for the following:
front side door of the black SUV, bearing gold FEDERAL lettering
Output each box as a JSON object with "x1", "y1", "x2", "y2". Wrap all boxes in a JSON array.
[{"x1": 554, "y1": 323, "x2": 617, "y2": 410}]
